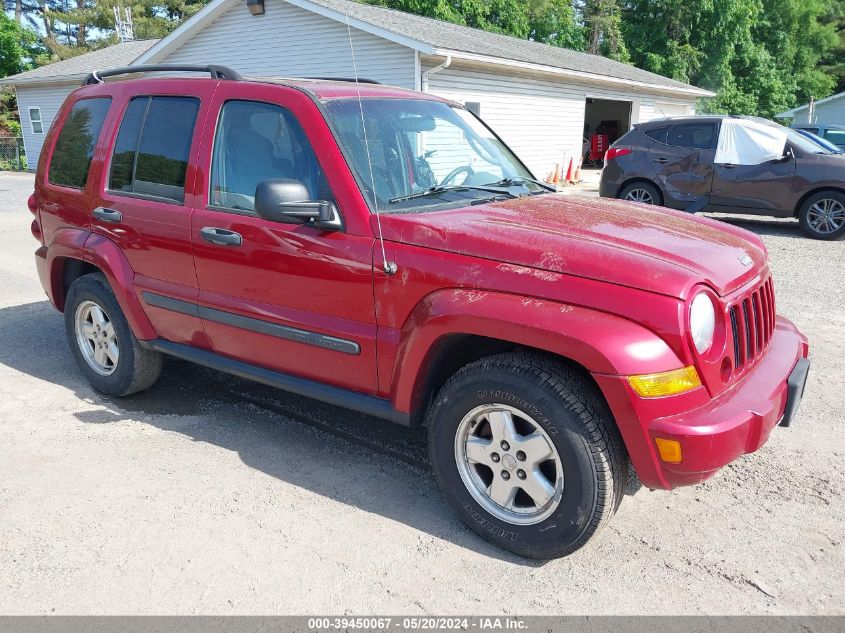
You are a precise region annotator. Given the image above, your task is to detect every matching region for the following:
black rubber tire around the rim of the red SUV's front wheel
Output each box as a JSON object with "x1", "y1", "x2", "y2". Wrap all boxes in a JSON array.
[{"x1": 427, "y1": 353, "x2": 628, "y2": 560}]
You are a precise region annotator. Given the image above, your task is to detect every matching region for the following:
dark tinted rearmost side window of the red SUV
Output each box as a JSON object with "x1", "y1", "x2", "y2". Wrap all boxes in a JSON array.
[{"x1": 48, "y1": 98, "x2": 111, "y2": 189}]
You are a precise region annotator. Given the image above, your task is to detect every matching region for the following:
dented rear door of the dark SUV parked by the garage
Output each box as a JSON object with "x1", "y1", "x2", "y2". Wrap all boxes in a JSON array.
[{"x1": 648, "y1": 122, "x2": 718, "y2": 209}]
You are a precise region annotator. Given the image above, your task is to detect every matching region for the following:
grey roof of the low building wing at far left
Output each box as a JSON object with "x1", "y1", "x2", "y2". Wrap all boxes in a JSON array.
[{"x1": 0, "y1": 40, "x2": 158, "y2": 85}]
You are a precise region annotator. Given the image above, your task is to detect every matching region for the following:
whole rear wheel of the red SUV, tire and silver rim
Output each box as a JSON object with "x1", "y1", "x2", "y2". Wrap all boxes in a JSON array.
[{"x1": 65, "y1": 273, "x2": 162, "y2": 396}]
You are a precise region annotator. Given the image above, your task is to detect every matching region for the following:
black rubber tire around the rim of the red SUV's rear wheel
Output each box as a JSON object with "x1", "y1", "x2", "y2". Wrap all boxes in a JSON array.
[{"x1": 65, "y1": 273, "x2": 162, "y2": 396}]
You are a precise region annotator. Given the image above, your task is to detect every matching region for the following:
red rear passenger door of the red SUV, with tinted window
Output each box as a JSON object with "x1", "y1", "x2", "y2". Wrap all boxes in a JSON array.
[{"x1": 91, "y1": 81, "x2": 215, "y2": 346}]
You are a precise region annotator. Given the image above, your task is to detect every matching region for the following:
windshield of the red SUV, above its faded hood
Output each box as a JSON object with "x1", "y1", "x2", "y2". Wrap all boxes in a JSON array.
[{"x1": 326, "y1": 99, "x2": 545, "y2": 212}]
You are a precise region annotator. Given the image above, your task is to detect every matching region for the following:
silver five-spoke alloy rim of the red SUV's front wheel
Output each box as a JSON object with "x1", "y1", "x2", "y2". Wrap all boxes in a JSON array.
[{"x1": 455, "y1": 404, "x2": 563, "y2": 525}]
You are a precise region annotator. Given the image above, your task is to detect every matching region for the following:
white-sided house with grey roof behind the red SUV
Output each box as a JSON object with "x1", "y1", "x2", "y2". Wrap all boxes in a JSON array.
[{"x1": 0, "y1": 0, "x2": 713, "y2": 173}]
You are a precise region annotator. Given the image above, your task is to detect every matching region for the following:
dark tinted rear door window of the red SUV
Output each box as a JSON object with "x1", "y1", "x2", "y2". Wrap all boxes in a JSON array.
[{"x1": 109, "y1": 97, "x2": 199, "y2": 202}]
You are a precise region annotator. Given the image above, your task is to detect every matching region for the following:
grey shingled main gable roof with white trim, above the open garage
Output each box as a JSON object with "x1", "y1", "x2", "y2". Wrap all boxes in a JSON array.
[{"x1": 136, "y1": 0, "x2": 713, "y2": 96}]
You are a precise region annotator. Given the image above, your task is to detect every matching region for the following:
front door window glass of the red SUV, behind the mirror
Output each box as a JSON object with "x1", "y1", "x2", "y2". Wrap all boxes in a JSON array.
[{"x1": 209, "y1": 101, "x2": 332, "y2": 211}]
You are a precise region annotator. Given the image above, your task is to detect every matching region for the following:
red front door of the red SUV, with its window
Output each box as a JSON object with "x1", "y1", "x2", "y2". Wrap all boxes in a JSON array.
[{"x1": 191, "y1": 82, "x2": 376, "y2": 393}]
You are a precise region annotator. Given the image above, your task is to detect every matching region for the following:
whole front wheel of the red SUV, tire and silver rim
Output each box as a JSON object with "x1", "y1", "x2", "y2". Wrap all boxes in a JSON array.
[{"x1": 428, "y1": 354, "x2": 627, "y2": 559}]
